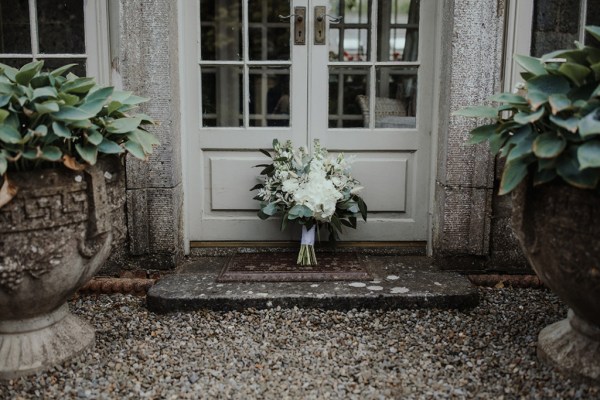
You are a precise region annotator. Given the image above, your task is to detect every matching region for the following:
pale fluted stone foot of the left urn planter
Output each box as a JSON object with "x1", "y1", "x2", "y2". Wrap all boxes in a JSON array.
[{"x1": 0, "y1": 304, "x2": 95, "y2": 379}]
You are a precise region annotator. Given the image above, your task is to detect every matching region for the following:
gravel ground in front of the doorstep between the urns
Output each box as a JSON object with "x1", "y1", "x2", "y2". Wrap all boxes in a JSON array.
[{"x1": 0, "y1": 288, "x2": 600, "y2": 399}]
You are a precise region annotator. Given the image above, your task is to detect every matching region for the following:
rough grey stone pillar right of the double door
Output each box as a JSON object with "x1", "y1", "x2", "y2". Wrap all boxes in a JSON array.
[{"x1": 433, "y1": 0, "x2": 505, "y2": 269}]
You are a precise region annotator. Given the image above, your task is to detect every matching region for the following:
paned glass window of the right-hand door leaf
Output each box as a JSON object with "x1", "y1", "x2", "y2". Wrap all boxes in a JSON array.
[{"x1": 327, "y1": 0, "x2": 420, "y2": 129}]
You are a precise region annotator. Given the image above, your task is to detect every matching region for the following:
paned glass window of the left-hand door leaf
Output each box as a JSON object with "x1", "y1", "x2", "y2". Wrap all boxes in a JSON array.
[{"x1": 199, "y1": 0, "x2": 292, "y2": 127}]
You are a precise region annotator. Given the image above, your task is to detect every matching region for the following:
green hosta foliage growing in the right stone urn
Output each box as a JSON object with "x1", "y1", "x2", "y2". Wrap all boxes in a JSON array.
[{"x1": 455, "y1": 26, "x2": 600, "y2": 194}]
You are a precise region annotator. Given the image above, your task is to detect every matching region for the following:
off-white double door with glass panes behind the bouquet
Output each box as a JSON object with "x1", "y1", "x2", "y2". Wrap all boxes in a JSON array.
[{"x1": 180, "y1": 0, "x2": 436, "y2": 242}]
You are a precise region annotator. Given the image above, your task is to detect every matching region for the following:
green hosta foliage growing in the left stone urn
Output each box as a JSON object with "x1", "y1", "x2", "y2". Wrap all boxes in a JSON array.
[{"x1": 0, "y1": 61, "x2": 158, "y2": 206}]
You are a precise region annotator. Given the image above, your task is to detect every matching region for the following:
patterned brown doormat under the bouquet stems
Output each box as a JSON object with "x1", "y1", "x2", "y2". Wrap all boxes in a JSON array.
[{"x1": 217, "y1": 253, "x2": 372, "y2": 282}]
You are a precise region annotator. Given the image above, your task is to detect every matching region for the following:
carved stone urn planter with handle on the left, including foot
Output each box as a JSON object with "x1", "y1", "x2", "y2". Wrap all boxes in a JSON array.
[{"x1": 0, "y1": 159, "x2": 124, "y2": 379}]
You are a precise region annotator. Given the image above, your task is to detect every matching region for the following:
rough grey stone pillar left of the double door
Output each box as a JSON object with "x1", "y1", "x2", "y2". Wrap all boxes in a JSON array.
[{"x1": 105, "y1": 0, "x2": 183, "y2": 271}]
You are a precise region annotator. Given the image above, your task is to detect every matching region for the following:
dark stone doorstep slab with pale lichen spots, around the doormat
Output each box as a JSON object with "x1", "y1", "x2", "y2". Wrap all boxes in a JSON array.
[{"x1": 146, "y1": 255, "x2": 479, "y2": 313}]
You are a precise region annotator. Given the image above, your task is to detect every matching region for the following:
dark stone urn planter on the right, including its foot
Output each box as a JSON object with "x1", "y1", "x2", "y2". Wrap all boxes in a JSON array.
[{"x1": 512, "y1": 182, "x2": 600, "y2": 382}]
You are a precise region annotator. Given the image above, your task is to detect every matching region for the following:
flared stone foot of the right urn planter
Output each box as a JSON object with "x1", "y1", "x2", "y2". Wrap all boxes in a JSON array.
[{"x1": 537, "y1": 311, "x2": 600, "y2": 383}]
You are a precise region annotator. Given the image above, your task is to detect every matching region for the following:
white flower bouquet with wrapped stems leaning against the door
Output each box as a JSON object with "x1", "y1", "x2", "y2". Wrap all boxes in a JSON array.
[{"x1": 250, "y1": 139, "x2": 367, "y2": 265}]
